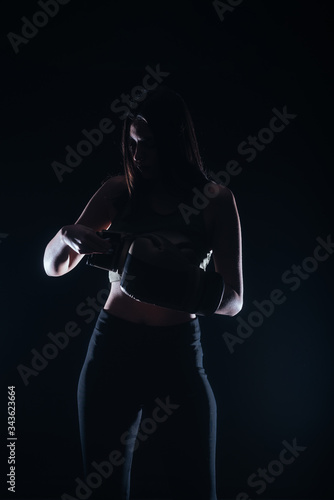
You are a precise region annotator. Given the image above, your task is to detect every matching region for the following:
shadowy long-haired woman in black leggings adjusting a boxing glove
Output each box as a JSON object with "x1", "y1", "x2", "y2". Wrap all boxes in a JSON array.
[{"x1": 44, "y1": 87, "x2": 243, "y2": 500}]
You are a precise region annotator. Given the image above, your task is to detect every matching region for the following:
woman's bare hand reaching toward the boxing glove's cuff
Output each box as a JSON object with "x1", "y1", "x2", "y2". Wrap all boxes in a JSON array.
[{"x1": 61, "y1": 224, "x2": 111, "y2": 255}]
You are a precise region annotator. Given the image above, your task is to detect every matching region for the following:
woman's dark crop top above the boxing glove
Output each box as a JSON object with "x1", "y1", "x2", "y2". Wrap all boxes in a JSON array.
[{"x1": 109, "y1": 193, "x2": 212, "y2": 282}]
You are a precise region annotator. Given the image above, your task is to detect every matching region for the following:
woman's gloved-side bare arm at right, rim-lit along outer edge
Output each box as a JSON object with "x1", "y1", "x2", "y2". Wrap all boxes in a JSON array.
[{"x1": 211, "y1": 186, "x2": 243, "y2": 316}]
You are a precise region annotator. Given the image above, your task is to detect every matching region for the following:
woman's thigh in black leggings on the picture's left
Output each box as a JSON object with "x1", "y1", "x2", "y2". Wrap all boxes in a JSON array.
[{"x1": 78, "y1": 322, "x2": 142, "y2": 500}]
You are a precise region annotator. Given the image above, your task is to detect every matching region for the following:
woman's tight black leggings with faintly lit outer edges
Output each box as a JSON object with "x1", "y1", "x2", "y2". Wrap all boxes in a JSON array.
[{"x1": 78, "y1": 310, "x2": 217, "y2": 500}]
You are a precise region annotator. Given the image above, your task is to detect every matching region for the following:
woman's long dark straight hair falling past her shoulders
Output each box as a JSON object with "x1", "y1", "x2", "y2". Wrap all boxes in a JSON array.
[{"x1": 122, "y1": 85, "x2": 207, "y2": 203}]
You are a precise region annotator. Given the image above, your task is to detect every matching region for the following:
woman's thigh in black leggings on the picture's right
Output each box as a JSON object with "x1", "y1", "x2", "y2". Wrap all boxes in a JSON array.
[{"x1": 138, "y1": 329, "x2": 217, "y2": 500}]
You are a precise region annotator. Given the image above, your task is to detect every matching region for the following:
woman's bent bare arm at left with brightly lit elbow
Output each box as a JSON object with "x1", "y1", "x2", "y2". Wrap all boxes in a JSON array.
[{"x1": 43, "y1": 176, "x2": 125, "y2": 276}]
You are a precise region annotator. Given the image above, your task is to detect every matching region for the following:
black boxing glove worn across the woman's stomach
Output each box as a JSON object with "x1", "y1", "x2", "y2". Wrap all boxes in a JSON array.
[{"x1": 121, "y1": 234, "x2": 225, "y2": 316}]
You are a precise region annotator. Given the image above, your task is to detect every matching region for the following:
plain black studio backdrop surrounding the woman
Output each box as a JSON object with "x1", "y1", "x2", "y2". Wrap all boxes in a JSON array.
[{"x1": 0, "y1": 0, "x2": 334, "y2": 499}]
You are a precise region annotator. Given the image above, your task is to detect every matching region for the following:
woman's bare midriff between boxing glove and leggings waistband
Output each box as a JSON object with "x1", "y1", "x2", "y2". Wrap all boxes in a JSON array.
[{"x1": 104, "y1": 281, "x2": 196, "y2": 326}]
